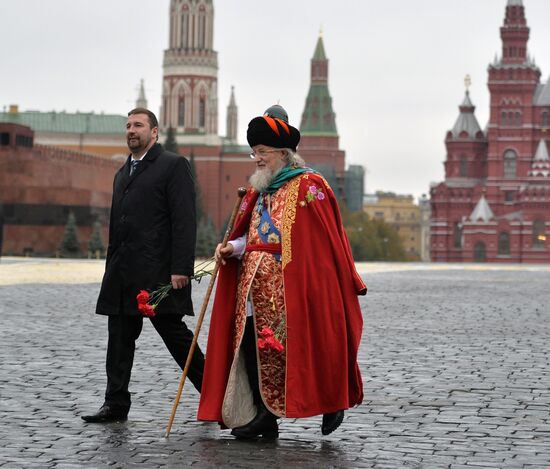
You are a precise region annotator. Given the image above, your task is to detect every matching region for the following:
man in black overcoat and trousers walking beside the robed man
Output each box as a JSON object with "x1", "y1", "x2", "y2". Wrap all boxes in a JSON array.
[{"x1": 82, "y1": 108, "x2": 204, "y2": 422}]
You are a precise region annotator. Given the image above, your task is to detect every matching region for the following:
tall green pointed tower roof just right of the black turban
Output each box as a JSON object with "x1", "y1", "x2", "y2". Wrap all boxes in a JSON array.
[{"x1": 300, "y1": 36, "x2": 338, "y2": 133}]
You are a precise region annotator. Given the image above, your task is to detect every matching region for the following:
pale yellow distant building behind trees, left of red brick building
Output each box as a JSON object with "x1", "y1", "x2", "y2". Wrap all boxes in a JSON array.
[{"x1": 363, "y1": 192, "x2": 425, "y2": 260}]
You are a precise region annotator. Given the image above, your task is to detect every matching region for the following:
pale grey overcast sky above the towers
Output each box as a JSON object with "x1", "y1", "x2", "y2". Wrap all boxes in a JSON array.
[{"x1": 0, "y1": 0, "x2": 550, "y2": 196}]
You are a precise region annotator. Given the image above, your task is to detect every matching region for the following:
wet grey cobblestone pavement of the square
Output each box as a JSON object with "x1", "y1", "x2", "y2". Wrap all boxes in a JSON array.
[{"x1": 0, "y1": 259, "x2": 550, "y2": 468}]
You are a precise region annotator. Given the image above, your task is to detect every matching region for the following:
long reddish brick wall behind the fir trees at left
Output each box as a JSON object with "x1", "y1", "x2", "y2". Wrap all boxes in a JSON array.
[{"x1": 0, "y1": 146, "x2": 121, "y2": 255}]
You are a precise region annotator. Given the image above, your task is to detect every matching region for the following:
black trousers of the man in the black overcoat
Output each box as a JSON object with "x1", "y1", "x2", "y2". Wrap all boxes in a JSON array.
[{"x1": 105, "y1": 315, "x2": 204, "y2": 411}]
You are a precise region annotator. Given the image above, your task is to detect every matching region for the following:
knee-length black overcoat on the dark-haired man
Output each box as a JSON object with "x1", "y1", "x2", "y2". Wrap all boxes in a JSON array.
[{"x1": 96, "y1": 143, "x2": 196, "y2": 315}]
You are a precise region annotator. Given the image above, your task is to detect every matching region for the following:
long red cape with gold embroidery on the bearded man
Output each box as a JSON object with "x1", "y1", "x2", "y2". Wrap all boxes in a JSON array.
[{"x1": 198, "y1": 173, "x2": 367, "y2": 422}]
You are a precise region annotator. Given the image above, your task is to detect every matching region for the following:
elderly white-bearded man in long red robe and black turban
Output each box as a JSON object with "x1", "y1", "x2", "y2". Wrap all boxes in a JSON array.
[{"x1": 198, "y1": 106, "x2": 367, "y2": 438}]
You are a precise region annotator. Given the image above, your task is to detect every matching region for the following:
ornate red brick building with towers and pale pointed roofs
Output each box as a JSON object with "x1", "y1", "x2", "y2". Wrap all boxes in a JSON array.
[{"x1": 430, "y1": 0, "x2": 550, "y2": 262}]
